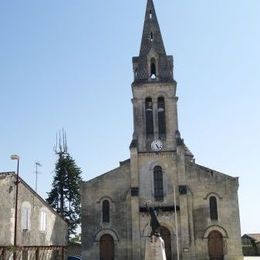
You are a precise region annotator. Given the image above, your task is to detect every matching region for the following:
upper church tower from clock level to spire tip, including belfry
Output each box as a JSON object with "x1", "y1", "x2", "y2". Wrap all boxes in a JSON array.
[{"x1": 131, "y1": 0, "x2": 178, "y2": 152}]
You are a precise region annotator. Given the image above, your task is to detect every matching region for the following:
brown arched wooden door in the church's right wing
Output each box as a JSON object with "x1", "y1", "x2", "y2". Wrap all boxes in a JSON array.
[{"x1": 208, "y1": 231, "x2": 224, "y2": 260}]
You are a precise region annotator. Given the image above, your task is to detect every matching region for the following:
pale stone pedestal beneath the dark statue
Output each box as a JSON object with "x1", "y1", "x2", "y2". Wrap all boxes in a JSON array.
[{"x1": 144, "y1": 235, "x2": 166, "y2": 260}]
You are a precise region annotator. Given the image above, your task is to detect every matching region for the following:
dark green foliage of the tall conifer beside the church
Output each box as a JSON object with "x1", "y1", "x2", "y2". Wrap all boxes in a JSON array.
[{"x1": 47, "y1": 153, "x2": 82, "y2": 237}]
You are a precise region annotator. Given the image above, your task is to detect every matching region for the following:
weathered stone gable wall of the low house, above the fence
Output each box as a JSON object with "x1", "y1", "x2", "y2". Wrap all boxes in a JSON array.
[{"x1": 0, "y1": 173, "x2": 67, "y2": 246}]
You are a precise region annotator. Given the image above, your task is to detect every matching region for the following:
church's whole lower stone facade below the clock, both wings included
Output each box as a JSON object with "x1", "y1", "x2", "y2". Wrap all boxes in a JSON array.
[{"x1": 81, "y1": 148, "x2": 242, "y2": 260}]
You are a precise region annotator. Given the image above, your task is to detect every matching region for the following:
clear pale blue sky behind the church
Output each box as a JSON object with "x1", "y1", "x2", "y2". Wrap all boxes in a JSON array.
[{"x1": 0, "y1": 0, "x2": 260, "y2": 236}]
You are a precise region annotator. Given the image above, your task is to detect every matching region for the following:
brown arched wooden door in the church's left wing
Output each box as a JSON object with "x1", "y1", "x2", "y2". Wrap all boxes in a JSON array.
[{"x1": 99, "y1": 234, "x2": 115, "y2": 260}]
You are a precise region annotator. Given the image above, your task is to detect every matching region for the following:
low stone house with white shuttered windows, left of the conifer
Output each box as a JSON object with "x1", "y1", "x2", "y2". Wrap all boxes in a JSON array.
[{"x1": 0, "y1": 172, "x2": 67, "y2": 259}]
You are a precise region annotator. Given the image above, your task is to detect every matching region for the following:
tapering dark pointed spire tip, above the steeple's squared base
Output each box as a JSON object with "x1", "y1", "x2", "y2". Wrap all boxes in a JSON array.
[{"x1": 139, "y1": 0, "x2": 166, "y2": 56}]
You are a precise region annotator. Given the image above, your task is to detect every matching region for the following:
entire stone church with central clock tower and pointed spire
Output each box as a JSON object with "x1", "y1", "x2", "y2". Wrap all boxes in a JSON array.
[{"x1": 81, "y1": 0, "x2": 243, "y2": 260}]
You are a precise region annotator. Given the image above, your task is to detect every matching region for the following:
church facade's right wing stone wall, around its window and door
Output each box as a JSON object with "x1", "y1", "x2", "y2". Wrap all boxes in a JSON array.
[{"x1": 186, "y1": 163, "x2": 242, "y2": 259}]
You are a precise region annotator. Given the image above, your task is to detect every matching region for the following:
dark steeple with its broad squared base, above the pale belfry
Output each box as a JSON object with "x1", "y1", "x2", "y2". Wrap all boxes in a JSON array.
[{"x1": 133, "y1": 0, "x2": 173, "y2": 83}]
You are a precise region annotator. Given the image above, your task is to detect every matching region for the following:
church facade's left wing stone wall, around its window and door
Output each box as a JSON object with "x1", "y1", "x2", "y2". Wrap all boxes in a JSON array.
[{"x1": 81, "y1": 161, "x2": 131, "y2": 260}]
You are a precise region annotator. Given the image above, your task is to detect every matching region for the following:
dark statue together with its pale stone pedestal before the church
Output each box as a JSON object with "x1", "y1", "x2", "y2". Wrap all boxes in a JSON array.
[{"x1": 145, "y1": 207, "x2": 166, "y2": 260}]
